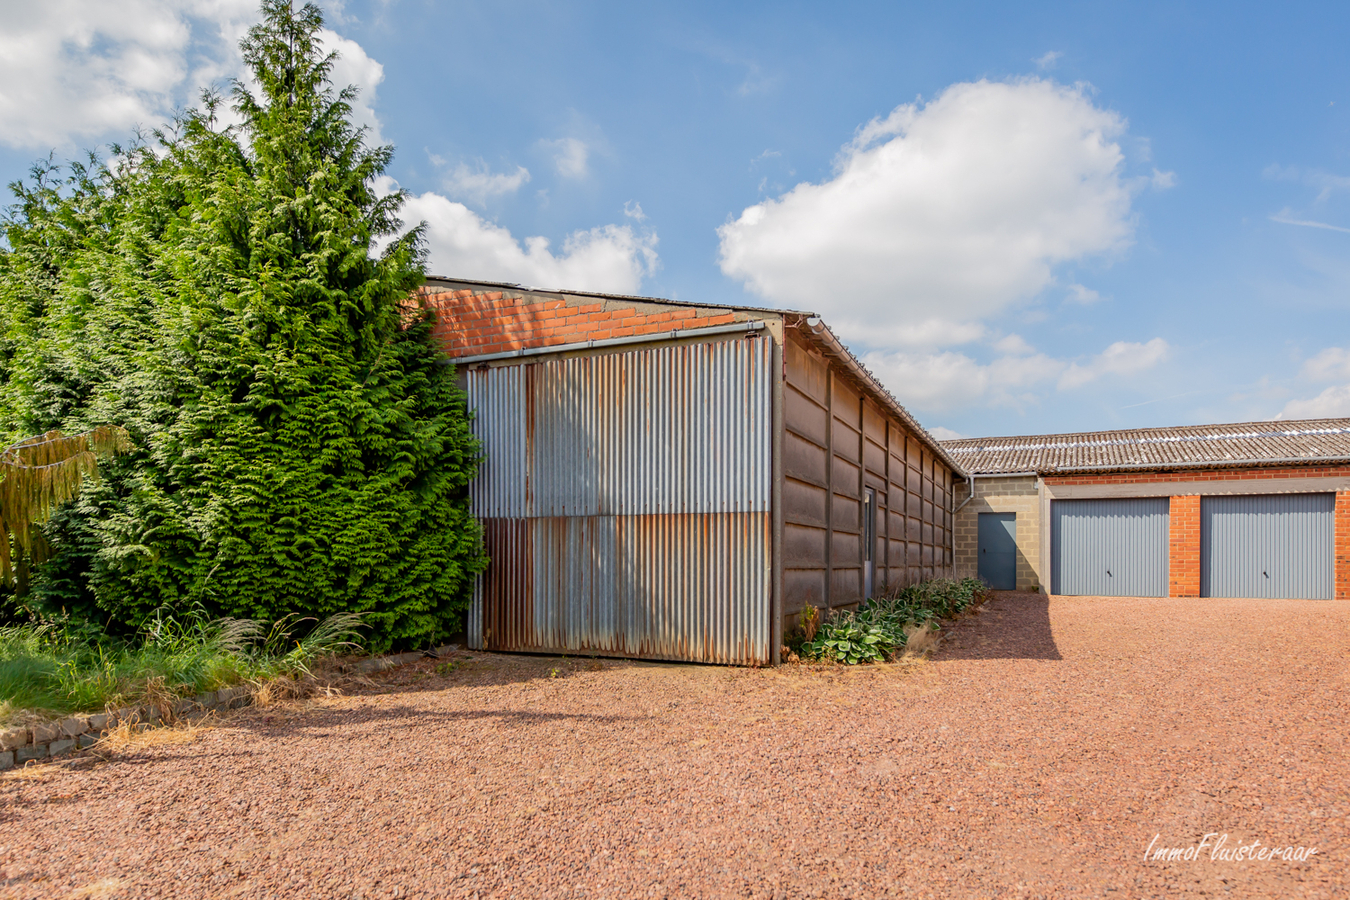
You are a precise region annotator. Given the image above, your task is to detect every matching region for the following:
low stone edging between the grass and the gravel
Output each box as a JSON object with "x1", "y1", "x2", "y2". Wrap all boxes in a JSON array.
[{"x1": 0, "y1": 644, "x2": 459, "y2": 772}]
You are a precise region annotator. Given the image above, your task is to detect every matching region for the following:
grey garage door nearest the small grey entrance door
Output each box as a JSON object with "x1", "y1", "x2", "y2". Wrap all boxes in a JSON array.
[{"x1": 1050, "y1": 497, "x2": 1169, "y2": 596}]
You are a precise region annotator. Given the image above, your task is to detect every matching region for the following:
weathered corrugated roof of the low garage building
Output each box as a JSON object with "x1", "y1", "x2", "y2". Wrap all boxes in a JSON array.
[{"x1": 942, "y1": 418, "x2": 1350, "y2": 475}]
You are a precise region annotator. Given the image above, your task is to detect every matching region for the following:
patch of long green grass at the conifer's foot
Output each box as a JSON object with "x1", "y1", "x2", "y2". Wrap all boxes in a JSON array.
[{"x1": 0, "y1": 611, "x2": 360, "y2": 725}]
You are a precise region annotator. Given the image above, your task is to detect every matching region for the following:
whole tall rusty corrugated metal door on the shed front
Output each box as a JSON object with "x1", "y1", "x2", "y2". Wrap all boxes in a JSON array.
[{"x1": 464, "y1": 337, "x2": 772, "y2": 664}]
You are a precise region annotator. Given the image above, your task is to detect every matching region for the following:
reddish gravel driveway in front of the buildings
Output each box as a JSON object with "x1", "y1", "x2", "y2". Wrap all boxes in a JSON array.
[{"x1": 0, "y1": 594, "x2": 1350, "y2": 899}]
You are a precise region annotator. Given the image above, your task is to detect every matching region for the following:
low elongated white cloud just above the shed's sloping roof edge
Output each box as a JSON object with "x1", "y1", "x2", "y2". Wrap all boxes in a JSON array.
[{"x1": 863, "y1": 335, "x2": 1169, "y2": 412}]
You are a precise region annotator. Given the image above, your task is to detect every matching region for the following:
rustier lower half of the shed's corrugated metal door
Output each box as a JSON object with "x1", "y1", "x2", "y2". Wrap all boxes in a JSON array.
[{"x1": 470, "y1": 513, "x2": 771, "y2": 664}]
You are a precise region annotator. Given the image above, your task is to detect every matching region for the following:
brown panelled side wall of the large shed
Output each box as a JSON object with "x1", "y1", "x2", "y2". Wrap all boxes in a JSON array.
[{"x1": 782, "y1": 331, "x2": 953, "y2": 619}]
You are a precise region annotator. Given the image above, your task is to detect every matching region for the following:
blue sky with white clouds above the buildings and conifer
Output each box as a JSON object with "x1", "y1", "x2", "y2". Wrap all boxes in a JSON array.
[{"x1": 0, "y1": 0, "x2": 1350, "y2": 436}]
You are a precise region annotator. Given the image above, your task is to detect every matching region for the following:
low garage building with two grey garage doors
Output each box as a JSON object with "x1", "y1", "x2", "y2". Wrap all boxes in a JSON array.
[{"x1": 944, "y1": 418, "x2": 1350, "y2": 599}]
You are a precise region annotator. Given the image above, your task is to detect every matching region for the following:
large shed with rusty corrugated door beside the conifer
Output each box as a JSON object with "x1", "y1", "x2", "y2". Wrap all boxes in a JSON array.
[{"x1": 421, "y1": 278, "x2": 964, "y2": 664}]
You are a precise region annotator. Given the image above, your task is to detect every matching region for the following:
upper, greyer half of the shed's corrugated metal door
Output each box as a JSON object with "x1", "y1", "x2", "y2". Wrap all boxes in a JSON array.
[{"x1": 464, "y1": 339, "x2": 772, "y2": 518}]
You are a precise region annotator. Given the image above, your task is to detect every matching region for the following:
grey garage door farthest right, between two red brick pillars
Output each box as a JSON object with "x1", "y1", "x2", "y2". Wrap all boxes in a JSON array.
[{"x1": 1200, "y1": 494, "x2": 1337, "y2": 600}]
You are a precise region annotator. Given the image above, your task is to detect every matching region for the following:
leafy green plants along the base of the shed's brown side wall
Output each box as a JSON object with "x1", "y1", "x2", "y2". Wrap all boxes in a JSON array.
[{"x1": 795, "y1": 578, "x2": 987, "y2": 665}]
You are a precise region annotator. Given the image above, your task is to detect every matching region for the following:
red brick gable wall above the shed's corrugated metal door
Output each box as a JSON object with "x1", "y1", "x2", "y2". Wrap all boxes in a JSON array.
[{"x1": 420, "y1": 287, "x2": 747, "y2": 356}]
